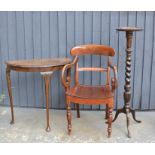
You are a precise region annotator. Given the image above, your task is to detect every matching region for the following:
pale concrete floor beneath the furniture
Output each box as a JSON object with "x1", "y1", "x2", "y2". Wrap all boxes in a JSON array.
[{"x1": 0, "y1": 107, "x2": 155, "y2": 143}]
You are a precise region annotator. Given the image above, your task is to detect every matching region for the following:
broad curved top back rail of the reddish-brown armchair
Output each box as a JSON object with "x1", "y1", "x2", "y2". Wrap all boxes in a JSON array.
[{"x1": 70, "y1": 44, "x2": 115, "y2": 56}]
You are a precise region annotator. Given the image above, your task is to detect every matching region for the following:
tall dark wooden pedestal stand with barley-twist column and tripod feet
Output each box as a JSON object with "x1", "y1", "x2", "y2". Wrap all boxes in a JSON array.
[{"x1": 113, "y1": 27, "x2": 142, "y2": 138}]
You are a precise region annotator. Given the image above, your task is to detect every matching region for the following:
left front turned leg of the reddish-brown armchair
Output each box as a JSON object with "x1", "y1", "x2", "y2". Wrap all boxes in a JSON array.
[{"x1": 66, "y1": 99, "x2": 72, "y2": 135}]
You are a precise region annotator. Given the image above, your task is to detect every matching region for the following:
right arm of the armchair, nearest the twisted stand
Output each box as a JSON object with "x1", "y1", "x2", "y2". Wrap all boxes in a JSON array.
[{"x1": 108, "y1": 62, "x2": 118, "y2": 89}]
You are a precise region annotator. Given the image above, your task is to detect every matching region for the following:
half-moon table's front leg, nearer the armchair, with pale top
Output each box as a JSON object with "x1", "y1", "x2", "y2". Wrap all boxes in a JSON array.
[{"x1": 41, "y1": 73, "x2": 51, "y2": 132}]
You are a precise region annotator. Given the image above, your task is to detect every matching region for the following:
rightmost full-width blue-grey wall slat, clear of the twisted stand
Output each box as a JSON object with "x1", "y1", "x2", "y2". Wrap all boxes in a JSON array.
[{"x1": 141, "y1": 12, "x2": 153, "y2": 109}]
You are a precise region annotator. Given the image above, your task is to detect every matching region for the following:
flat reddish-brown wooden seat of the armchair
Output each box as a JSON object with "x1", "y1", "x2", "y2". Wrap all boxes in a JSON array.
[{"x1": 66, "y1": 85, "x2": 114, "y2": 99}]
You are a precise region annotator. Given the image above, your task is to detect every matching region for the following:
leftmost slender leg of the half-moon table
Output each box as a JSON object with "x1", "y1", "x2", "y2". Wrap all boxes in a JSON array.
[{"x1": 6, "y1": 67, "x2": 14, "y2": 124}]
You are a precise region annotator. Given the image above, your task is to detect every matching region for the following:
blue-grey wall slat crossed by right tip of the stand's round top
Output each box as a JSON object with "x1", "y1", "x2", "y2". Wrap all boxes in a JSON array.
[{"x1": 133, "y1": 12, "x2": 145, "y2": 109}]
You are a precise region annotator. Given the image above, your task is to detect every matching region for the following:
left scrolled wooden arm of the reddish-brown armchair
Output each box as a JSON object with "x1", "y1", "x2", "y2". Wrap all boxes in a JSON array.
[{"x1": 61, "y1": 56, "x2": 78, "y2": 88}]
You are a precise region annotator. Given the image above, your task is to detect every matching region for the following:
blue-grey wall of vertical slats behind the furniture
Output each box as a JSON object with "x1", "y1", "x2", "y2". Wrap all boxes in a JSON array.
[{"x1": 0, "y1": 12, "x2": 155, "y2": 110}]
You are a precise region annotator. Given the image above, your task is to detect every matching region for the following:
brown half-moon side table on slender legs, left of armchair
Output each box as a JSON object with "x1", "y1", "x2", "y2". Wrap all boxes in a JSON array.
[{"x1": 6, "y1": 58, "x2": 70, "y2": 131}]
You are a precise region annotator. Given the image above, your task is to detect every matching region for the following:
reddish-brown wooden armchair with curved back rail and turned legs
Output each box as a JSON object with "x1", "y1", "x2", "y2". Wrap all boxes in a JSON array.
[{"x1": 61, "y1": 44, "x2": 117, "y2": 137}]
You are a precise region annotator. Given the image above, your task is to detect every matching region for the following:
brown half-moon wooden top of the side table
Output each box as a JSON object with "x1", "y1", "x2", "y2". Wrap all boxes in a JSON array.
[{"x1": 6, "y1": 58, "x2": 71, "y2": 72}]
